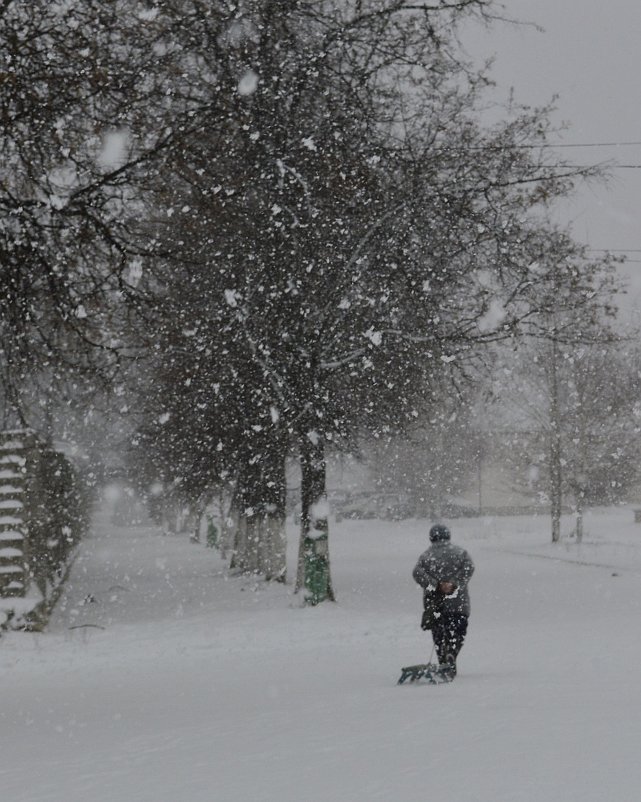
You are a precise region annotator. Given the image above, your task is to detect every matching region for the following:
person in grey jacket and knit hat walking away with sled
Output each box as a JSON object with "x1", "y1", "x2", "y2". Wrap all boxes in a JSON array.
[{"x1": 412, "y1": 524, "x2": 474, "y2": 679}]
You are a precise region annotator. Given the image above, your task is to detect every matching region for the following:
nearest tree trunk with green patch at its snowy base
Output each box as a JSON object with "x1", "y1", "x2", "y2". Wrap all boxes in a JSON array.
[{"x1": 295, "y1": 431, "x2": 335, "y2": 605}]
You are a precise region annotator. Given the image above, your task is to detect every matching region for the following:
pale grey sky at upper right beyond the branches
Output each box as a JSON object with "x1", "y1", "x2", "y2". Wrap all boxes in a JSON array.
[{"x1": 465, "y1": 0, "x2": 641, "y2": 322}]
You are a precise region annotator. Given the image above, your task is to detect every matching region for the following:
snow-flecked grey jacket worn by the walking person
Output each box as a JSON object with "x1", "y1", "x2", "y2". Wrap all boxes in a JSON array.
[{"x1": 412, "y1": 541, "x2": 474, "y2": 616}]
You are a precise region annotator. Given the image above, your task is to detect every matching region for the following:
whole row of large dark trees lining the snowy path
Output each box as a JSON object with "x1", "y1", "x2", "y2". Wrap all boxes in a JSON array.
[{"x1": 0, "y1": 0, "x2": 624, "y2": 598}]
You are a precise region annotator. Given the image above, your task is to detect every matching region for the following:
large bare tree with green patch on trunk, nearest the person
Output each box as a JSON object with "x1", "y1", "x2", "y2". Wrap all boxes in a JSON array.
[{"x1": 124, "y1": 0, "x2": 616, "y2": 600}]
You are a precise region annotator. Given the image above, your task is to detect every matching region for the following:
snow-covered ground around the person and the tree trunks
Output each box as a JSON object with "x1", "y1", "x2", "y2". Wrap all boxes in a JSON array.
[{"x1": 0, "y1": 508, "x2": 641, "y2": 802}]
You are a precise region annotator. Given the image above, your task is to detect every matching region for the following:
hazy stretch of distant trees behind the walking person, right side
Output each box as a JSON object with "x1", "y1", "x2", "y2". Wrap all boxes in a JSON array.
[{"x1": 363, "y1": 321, "x2": 641, "y2": 541}]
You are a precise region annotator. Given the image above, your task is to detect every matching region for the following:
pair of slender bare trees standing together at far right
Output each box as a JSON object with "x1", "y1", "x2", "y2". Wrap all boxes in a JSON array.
[{"x1": 488, "y1": 331, "x2": 641, "y2": 542}]
